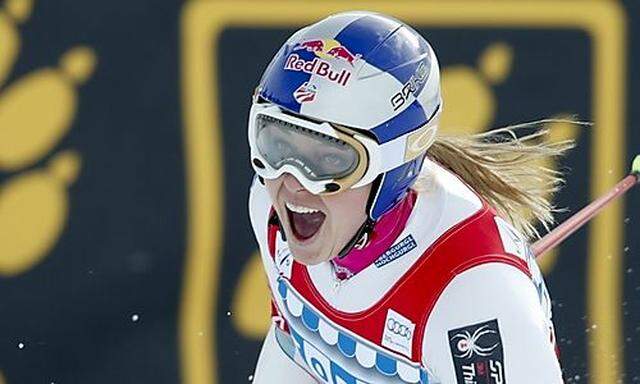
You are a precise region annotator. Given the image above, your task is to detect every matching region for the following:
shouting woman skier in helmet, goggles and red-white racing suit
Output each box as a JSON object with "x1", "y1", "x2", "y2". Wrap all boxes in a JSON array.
[{"x1": 249, "y1": 12, "x2": 569, "y2": 384}]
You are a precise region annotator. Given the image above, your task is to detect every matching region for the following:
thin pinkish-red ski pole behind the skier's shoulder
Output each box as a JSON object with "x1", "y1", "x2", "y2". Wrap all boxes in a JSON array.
[{"x1": 531, "y1": 155, "x2": 640, "y2": 257}]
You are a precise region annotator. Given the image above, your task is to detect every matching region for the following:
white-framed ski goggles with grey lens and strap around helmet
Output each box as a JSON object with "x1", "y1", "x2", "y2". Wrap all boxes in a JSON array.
[{"x1": 249, "y1": 104, "x2": 437, "y2": 194}]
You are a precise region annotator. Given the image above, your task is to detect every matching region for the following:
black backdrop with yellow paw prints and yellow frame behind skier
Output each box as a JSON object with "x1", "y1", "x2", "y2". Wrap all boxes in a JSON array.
[{"x1": 0, "y1": 0, "x2": 640, "y2": 384}]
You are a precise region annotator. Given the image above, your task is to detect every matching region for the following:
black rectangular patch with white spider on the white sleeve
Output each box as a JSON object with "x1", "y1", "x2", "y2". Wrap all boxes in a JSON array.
[{"x1": 449, "y1": 320, "x2": 506, "y2": 384}]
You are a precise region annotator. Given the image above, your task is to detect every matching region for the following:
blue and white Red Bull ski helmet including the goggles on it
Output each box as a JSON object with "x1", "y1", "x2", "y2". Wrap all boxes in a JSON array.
[{"x1": 249, "y1": 12, "x2": 442, "y2": 222}]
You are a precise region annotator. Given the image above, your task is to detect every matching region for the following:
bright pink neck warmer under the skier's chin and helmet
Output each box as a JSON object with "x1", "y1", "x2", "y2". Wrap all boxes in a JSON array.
[{"x1": 332, "y1": 190, "x2": 417, "y2": 280}]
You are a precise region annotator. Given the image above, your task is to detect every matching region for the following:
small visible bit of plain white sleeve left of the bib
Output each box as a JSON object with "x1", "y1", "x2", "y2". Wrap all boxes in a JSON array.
[{"x1": 253, "y1": 325, "x2": 317, "y2": 384}]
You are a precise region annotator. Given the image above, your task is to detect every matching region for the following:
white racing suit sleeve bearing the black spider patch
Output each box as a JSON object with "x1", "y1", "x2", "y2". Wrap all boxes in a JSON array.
[{"x1": 422, "y1": 263, "x2": 563, "y2": 384}]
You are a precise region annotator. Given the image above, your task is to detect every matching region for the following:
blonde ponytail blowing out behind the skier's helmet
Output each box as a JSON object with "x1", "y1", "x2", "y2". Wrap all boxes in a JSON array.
[{"x1": 418, "y1": 119, "x2": 589, "y2": 239}]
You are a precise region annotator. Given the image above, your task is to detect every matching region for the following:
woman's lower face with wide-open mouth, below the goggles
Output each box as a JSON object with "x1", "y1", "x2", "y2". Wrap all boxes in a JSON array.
[{"x1": 265, "y1": 173, "x2": 371, "y2": 265}]
